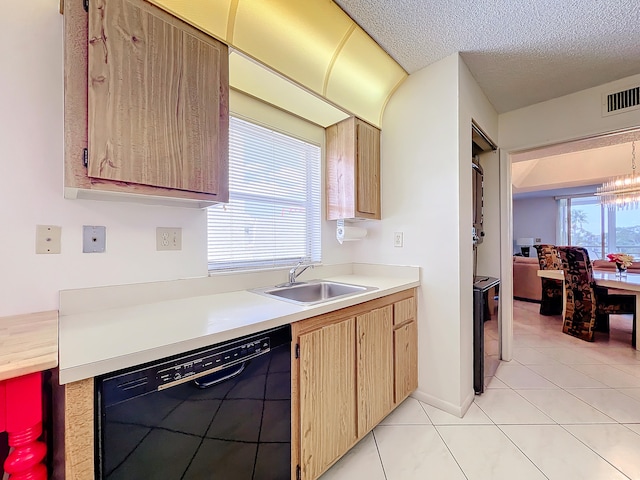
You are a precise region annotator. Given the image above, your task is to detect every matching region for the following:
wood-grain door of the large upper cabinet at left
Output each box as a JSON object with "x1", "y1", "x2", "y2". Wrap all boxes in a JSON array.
[{"x1": 88, "y1": 0, "x2": 228, "y2": 196}]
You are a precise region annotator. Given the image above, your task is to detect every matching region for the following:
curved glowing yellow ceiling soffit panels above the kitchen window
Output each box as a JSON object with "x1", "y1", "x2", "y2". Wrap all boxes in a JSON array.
[{"x1": 150, "y1": 0, "x2": 407, "y2": 127}]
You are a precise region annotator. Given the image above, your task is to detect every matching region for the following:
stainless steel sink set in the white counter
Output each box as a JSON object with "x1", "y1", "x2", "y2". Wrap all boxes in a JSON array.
[{"x1": 252, "y1": 280, "x2": 377, "y2": 305}]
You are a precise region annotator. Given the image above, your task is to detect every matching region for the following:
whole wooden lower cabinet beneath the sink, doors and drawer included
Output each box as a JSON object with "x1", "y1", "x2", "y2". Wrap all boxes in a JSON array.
[{"x1": 291, "y1": 289, "x2": 418, "y2": 480}]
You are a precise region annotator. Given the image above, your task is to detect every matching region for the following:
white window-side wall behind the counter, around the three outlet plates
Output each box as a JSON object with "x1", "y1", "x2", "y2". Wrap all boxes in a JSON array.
[{"x1": 0, "y1": 0, "x2": 351, "y2": 316}]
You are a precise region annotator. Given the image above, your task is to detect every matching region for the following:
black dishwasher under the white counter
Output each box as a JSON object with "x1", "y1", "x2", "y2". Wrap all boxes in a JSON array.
[{"x1": 95, "y1": 325, "x2": 291, "y2": 480}]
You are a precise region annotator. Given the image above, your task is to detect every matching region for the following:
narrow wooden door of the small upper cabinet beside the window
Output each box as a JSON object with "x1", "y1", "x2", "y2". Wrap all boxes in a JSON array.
[{"x1": 356, "y1": 119, "x2": 380, "y2": 219}]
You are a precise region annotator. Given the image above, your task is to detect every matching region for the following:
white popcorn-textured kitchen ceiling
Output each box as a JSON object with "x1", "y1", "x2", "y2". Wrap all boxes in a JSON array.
[{"x1": 335, "y1": 0, "x2": 640, "y2": 113}]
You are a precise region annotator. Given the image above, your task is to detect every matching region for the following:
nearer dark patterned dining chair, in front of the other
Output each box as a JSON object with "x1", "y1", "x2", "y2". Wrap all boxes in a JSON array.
[{"x1": 557, "y1": 246, "x2": 636, "y2": 346}]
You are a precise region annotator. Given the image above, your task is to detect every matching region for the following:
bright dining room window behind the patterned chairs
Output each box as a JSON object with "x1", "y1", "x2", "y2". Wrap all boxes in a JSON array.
[{"x1": 558, "y1": 195, "x2": 640, "y2": 260}]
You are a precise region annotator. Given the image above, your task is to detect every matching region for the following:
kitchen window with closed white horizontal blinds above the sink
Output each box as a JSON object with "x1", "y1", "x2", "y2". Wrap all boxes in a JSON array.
[{"x1": 207, "y1": 116, "x2": 321, "y2": 270}]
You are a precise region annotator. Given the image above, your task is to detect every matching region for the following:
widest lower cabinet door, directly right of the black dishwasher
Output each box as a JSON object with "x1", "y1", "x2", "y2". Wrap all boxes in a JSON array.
[{"x1": 299, "y1": 318, "x2": 356, "y2": 479}]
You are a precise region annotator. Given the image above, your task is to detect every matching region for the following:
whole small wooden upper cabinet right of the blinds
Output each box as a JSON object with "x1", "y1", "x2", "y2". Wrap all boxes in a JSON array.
[{"x1": 326, "y1": 117, "x2": 380, "y2": 220}]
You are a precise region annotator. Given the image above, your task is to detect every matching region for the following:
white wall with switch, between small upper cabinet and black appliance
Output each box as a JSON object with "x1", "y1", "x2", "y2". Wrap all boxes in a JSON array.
[{"x1": 354, "y1": 54, "x2": 497, "y2": 414}]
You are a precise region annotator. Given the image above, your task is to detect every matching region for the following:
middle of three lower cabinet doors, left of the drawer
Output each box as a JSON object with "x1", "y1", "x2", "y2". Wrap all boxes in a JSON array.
[{"x1": 356, "y1": 305, "x2": 393, "y2": 437}]
